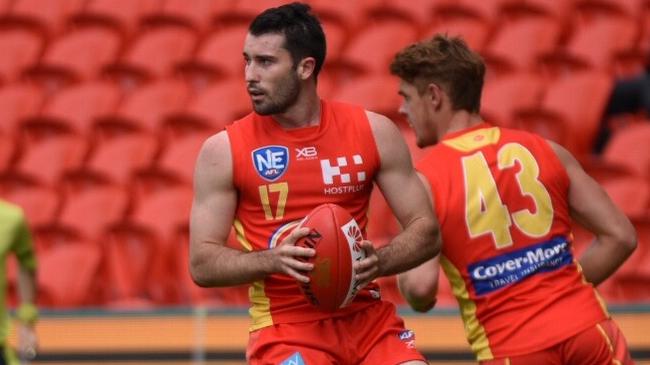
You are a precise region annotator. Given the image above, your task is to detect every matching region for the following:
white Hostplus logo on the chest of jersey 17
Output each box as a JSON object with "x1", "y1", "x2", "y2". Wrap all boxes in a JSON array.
[{"x1": 320, "y1": 155, "x2": 366, "y2": 195}]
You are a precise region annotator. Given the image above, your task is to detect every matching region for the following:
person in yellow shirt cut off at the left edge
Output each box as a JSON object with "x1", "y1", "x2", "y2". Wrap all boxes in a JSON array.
[{"x1": 0, "y1": 200, "x2": 38, "y2": 365}]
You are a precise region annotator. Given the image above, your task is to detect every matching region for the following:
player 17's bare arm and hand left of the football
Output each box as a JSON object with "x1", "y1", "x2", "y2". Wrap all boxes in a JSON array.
[{"x1": 190, "y1": 132, "x2": 314, "y2": 286}]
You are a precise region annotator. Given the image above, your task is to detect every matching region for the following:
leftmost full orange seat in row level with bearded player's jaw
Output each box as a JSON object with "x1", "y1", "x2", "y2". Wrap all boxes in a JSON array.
[{"x1": 23, "y1": 81, "x2": 121, "y2": 135}]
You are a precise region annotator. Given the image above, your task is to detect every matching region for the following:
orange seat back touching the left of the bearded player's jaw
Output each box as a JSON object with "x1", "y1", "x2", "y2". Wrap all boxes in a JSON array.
[{"x1": 177, "y1": 78, "x2": 252, "y2": 132}]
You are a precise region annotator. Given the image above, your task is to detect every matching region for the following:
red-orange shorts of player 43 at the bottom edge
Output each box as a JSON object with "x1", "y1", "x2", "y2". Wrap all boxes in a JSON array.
[{"x1": 481, "y1": 319, "x2": 634, "y2": 365}]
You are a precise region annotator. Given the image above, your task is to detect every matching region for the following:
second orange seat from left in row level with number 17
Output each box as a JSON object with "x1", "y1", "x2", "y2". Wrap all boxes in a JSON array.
[{"x1": 57, "y1": 170, "x2": 129, "y2": 239}]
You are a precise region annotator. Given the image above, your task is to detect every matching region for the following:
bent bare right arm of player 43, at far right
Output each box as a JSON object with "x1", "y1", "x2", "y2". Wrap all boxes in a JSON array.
[{"x1": 549, "y1": 142, "x2": 637, "y2": 285}]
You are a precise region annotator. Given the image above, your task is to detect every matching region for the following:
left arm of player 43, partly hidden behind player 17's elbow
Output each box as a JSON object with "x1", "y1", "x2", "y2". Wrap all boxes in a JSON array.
[{"x1": 397, "y1": 173, "x2": 440, "y2": 312}]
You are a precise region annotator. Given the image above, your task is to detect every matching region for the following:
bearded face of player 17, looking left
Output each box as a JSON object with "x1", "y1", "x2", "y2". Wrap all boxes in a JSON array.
[{"x1": 244, "y1": 33, "x2": 300, "y2": 115}]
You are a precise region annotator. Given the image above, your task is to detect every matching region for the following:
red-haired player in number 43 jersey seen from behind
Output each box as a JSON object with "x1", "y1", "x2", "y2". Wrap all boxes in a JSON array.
[{"x1": 390, "y1": 35, "x2": 636, "y2": 365}]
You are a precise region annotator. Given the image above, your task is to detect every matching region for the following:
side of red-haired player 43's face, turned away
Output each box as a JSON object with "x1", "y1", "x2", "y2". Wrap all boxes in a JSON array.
[{"x1": 399, "y1": 80, "x2": 438, "y2": 148}]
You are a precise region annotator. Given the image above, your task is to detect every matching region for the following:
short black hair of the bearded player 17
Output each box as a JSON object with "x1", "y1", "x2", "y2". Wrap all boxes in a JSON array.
[{"x1": 248, "y1": 2, "x2": 327, "y2": 78}]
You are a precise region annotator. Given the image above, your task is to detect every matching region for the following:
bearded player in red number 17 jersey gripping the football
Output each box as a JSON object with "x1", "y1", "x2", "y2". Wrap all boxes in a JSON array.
[{"x1": 190, "y1": 3, "x2": 439, "y2": 365}]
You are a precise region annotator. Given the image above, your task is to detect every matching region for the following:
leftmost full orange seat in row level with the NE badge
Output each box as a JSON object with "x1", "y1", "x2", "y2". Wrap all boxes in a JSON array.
[{"x1": 15, "y1": 132, "x2": 87, "y2": 186}]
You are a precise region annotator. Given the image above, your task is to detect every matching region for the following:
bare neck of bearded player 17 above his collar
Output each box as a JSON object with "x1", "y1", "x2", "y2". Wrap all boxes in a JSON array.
[{"x1": 273, "y1": 88, "x2": 321, "y2": 129}]
